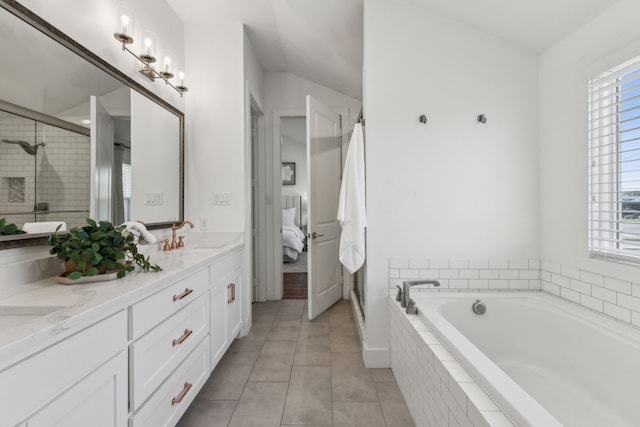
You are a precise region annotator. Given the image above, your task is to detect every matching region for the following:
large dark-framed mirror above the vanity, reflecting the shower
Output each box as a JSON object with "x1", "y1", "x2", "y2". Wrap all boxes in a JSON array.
[{"x1": 0, "y1": 0, "x2": 184, "y2": 249}]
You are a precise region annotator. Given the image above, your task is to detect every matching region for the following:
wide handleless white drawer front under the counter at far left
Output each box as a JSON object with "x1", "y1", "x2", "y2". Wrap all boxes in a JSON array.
[{"x1": 0, "y1": 310, "x2": 127, "y2": 425}]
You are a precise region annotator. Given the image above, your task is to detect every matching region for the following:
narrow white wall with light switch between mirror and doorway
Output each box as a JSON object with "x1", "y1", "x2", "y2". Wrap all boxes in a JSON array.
[{"x1": 186, "y1": 23, "x2": 246, "y2": 231}]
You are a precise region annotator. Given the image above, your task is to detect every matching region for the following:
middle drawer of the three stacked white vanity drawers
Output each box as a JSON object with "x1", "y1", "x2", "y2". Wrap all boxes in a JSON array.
[{"x1": 129, "y1": 293, "x2": 209, "y2": 410}]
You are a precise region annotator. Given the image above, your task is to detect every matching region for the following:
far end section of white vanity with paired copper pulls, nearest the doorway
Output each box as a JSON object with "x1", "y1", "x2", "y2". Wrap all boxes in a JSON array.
[{"x1": 210, "y1": 247, "x2": 242, "y2": 371}]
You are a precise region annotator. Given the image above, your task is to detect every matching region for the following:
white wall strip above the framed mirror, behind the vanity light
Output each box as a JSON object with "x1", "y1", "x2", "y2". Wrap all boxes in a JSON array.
[{"x1": 20, "y1": 0, "x2": 189, "y2": 110}]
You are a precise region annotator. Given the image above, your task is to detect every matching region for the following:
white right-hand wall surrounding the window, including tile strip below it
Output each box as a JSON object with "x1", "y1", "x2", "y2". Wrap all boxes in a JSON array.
[{"x1": 540, "y1": 1, "x2": 640, "y2": 326}]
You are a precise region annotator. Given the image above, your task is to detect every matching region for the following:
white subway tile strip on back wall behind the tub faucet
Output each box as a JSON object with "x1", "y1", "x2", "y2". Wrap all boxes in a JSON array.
[{"x1": 389, "y1": 258, "x2": 541, "y2": 292}]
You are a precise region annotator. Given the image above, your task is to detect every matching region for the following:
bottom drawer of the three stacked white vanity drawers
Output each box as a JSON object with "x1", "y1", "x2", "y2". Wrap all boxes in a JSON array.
[{"x1": 129, "y1": 338, "x2": 209, "y2": 427}]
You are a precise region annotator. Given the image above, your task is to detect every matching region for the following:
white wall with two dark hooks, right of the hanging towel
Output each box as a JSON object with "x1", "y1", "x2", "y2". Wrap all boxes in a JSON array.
[{"x1": 364, "y1": 0, "x2": 539, "y2": 366}]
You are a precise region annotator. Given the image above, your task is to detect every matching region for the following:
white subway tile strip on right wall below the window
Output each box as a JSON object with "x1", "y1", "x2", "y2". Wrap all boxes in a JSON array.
[{"x1": 540, "y1": 261, "x2": 640, "y2": 327}]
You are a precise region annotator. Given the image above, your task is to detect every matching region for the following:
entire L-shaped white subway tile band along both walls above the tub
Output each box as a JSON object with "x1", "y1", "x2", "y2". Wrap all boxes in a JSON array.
[{"x1": 389, "y1": 258, "x2": 640, "y2": 327}]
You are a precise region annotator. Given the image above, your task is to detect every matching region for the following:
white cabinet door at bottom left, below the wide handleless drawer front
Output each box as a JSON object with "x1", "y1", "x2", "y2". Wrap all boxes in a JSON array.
[{"x1": 28, "y1": 352, "x2": 128, "y2": 427}]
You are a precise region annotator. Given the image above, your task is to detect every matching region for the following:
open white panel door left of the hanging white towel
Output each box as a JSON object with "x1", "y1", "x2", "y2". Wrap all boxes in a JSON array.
[{"x1": 307, "y1": 96, "x2": 342, "y2": 319}]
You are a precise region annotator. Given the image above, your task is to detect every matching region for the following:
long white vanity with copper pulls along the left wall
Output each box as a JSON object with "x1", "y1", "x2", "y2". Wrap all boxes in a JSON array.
[{"x1": 0, "y1": 242, "x2": 243, "y2": 427}]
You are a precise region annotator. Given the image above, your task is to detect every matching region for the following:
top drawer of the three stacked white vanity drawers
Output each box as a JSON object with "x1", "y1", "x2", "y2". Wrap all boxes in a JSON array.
[{"x1": 129, "y1": 268, "x2": 209, "y2": 339}]
